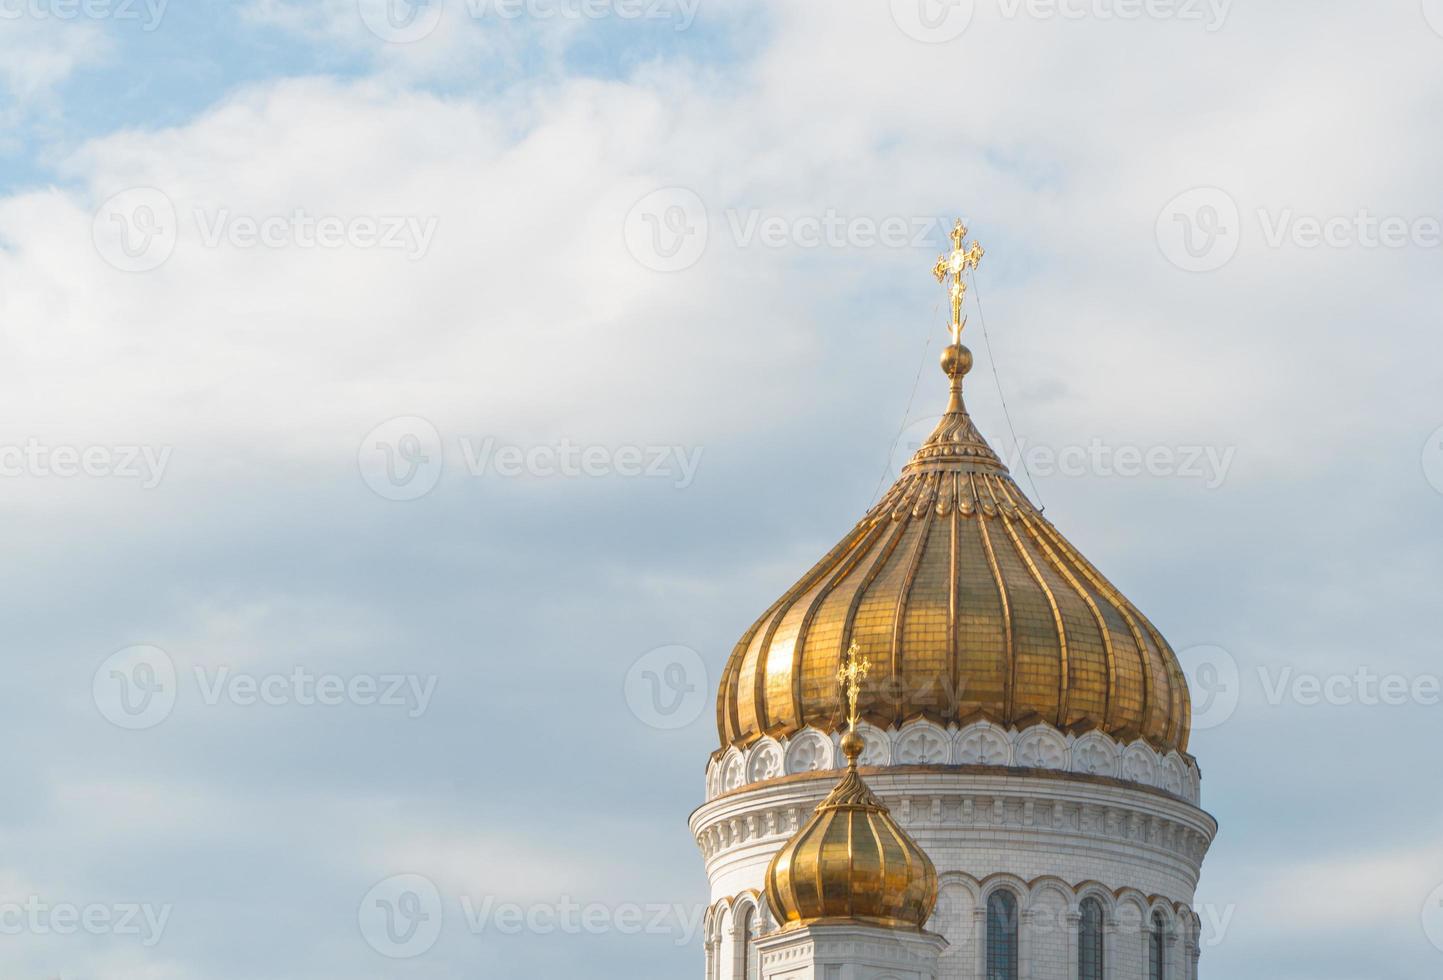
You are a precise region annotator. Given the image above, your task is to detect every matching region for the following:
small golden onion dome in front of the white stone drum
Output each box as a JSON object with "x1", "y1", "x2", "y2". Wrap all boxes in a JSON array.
[{"x1": 766, "y1": 733, "x2": 938, "y2": 929}]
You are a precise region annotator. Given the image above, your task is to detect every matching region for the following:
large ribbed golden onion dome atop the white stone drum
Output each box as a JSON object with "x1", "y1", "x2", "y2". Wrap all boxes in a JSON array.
[{"x1": 717, "y1": 337, "x2": 1192, "y2": 752}]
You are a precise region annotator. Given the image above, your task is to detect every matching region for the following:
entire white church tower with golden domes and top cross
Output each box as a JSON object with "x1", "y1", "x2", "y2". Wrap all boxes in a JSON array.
[{"x1": 691, "y1": 222, "x2": 1218, "y2": 980}]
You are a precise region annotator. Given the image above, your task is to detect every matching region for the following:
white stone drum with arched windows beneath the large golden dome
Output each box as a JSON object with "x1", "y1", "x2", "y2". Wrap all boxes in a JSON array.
[{"x1": 691, "y1": 723, "x2": 1216, "y2": 980}]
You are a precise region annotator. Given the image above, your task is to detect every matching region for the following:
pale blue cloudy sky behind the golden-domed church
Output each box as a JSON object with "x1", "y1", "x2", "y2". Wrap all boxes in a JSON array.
[{"x1": 0, "y1": 0, "x2": 1443, "y2": 980}]
